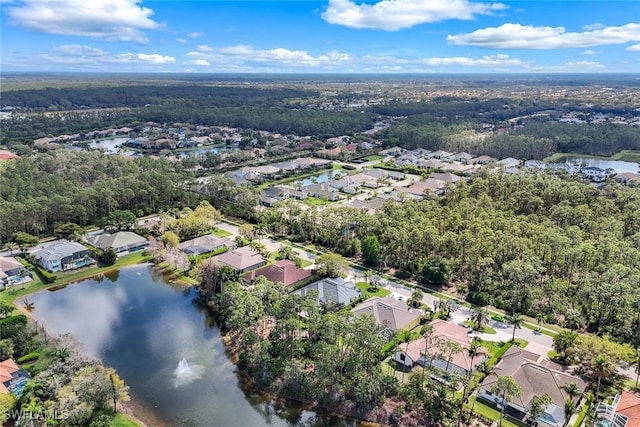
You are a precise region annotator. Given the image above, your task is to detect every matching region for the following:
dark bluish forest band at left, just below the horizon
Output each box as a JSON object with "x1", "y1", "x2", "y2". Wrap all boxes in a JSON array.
[{"x1": 1, "y1": 85, "x2": 378, "y2": 145}]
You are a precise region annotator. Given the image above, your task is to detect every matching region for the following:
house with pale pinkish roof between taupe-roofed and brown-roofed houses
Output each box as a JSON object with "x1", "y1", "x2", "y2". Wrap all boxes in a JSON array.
[{"x1": 392, "y1": 319, "x2": 489, "y2": 376}]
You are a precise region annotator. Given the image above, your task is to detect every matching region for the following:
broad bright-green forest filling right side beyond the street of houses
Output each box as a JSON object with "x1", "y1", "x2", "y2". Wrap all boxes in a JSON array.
[{"x1": 255, "y1": 172, "x2": 640, "y2": 342}]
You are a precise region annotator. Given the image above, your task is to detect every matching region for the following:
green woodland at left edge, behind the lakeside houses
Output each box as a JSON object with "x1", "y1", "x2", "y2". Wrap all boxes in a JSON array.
[{"x1": 0, "y1": 150, "x2": 199, "y2": 242}]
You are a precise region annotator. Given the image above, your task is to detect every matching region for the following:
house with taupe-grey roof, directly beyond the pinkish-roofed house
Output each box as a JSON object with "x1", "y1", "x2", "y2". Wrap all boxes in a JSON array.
[{"x1": 351, "y1": 296, "x2": 422, "y2": 331}]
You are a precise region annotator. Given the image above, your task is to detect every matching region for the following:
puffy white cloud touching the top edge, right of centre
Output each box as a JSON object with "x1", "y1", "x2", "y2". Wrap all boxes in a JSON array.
[{"x1": 322, "y1": 0, "x2": 507, "y2": 31}]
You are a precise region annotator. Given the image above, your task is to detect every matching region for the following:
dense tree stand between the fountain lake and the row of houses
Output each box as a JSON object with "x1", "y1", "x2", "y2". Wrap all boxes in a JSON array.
[{"x1": 199, "y1": 270, "x2": 460, "y2": 426}]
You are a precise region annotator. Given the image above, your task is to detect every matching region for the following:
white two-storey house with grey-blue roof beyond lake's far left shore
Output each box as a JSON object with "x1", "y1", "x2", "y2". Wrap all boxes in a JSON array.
[{"x1": 32, "y1": 240, "x2": 95, "y2": 272}]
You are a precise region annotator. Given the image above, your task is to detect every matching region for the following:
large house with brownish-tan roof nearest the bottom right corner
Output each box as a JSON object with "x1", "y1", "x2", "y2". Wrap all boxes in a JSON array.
[{"x1": 478, "y1": 346, "x2": 587, "y2": 427}]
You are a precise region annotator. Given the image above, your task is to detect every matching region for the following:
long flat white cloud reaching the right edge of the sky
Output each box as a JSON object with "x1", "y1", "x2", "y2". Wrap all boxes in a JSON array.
[{"x1": 447, "y1": 23, "x2": 640, "y2": 49}]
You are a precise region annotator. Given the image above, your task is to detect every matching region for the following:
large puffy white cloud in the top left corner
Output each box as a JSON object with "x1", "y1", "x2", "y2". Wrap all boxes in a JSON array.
[{"x1": 6, "y1": 0, "x2": 161, "y2": 43}]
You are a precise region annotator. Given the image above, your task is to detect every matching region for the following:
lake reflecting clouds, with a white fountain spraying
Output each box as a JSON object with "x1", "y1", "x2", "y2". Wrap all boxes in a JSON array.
[{"x1": 29, "y1": 264, "x2": 355, "y2": 427}]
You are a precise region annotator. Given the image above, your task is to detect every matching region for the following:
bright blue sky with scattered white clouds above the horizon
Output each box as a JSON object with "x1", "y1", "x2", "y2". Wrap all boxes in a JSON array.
[{"x1": 0, "y1": 0, "x2": 640, "y2": 73}]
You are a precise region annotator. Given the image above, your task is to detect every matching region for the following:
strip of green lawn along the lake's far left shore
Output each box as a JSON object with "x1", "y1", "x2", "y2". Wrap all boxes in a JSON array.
[{"x1": 0, "y1": 252, "x2": 151, "y2": 304}]
